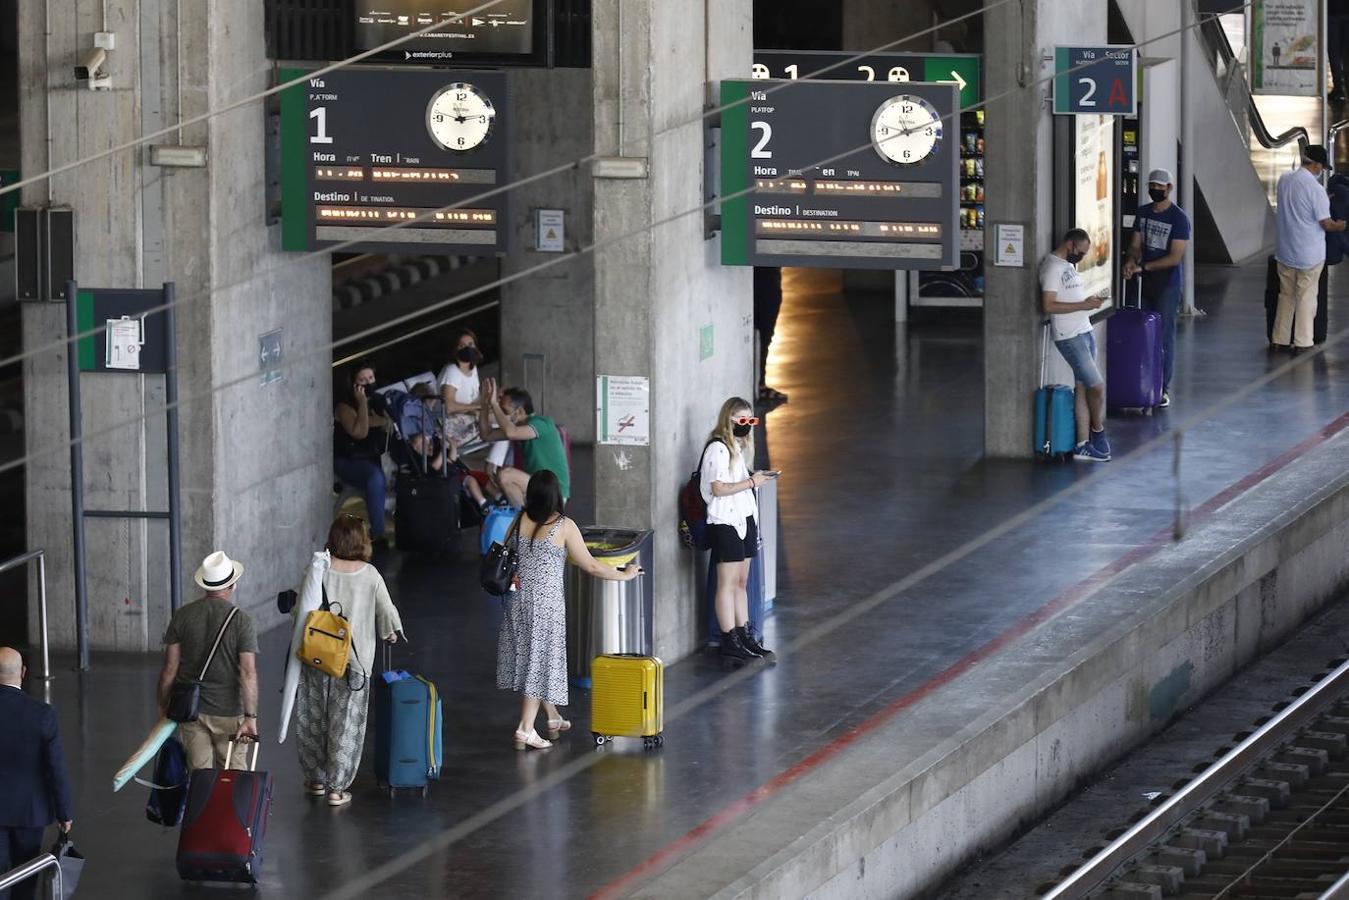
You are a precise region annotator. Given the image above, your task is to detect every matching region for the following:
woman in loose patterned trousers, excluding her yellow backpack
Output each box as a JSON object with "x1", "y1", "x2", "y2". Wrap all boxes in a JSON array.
[{"x1": 293, "y1": 515, "x2": 403, "y2": 807}]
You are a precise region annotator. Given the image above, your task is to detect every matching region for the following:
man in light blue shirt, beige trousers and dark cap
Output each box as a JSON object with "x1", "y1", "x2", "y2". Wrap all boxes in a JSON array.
[{"x1": 1269, "y1": 144, "x2": 1345, "y2": 354}]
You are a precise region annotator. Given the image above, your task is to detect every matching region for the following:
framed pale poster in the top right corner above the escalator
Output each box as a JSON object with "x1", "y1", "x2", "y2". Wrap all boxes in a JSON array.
[{"x1": 1251, "y1": 0, "x2": 1321, "y2": 97}]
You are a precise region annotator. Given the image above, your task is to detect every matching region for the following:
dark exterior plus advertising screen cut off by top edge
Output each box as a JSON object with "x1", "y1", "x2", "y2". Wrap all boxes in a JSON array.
[{"x1": 353, "y1": 0, "x2": 548, "y2": 66}]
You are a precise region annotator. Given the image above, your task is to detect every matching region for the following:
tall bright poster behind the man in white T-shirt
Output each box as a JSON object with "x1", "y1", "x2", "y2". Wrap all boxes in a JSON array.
[{"x1": 1072, "y1": 116, "x2": 1116, "y2": 294}]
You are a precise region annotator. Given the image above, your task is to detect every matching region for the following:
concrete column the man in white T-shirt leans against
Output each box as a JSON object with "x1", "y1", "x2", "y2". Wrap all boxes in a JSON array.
[{"x1": 983, "y1": 0, "x2": 1108, "y2": 457}]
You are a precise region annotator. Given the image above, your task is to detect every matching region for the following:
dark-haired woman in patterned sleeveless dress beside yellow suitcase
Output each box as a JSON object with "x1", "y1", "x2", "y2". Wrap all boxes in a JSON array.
[{"x1": 496, "y1": 468, "x2": 642, "y2": 750}]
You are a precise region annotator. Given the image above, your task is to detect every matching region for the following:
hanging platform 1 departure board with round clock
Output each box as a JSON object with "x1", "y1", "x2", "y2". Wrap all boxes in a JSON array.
[{"x1": 281, "y1": 69, "x2": 510, "y2": 255}]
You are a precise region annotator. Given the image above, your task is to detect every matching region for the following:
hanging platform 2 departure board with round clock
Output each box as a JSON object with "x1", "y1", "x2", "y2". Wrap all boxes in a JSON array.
[{"x1": 722, "y1": 80, "x2": 960, "y2": 270}]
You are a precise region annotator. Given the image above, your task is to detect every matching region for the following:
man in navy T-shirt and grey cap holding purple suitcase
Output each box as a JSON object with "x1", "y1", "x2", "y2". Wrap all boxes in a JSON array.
[{"x1": 1124, "y1": 169, "x2": 1190, "y2": 406}]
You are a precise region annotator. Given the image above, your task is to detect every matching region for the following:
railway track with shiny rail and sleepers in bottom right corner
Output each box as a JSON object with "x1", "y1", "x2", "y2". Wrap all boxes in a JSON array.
[{"x1": 1040, "y1": 660, "x2": 1349, "y2": 900}]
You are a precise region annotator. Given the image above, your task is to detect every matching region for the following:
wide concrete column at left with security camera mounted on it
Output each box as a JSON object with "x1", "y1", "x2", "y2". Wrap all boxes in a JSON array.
[{"x1": 19, "y1": 0, "x2": 332, "y2": 652}]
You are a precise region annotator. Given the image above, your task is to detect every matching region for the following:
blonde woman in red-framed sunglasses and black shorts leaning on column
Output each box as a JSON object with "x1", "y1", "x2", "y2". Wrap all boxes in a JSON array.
[{"x1": 700, "y1": 397, "x2": 777, "y2": 665}]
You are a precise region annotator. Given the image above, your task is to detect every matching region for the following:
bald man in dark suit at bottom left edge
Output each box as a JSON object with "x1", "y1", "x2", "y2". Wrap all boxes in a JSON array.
[{"x1": 0, "y1": 646, "x2": 73, "y2": 900}]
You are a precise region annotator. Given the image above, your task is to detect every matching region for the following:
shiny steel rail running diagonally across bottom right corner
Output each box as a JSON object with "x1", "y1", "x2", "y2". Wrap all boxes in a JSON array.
[{"x1": 1044, "y1": 663, "x2": 1349, "y2": 900}]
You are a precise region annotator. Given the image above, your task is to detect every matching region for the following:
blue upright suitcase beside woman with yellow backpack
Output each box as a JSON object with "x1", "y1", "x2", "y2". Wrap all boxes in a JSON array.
[{"x1": 375, "y1": 645, "x2": 444, "y2": 796}]
